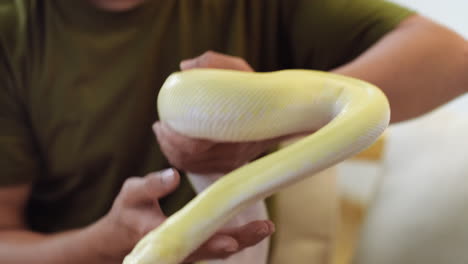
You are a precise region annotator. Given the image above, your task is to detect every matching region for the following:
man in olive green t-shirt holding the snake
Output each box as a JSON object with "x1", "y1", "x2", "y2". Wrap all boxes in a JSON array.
[{"x1": 0, "y1": 0, "x2": 468, "y2": 264}]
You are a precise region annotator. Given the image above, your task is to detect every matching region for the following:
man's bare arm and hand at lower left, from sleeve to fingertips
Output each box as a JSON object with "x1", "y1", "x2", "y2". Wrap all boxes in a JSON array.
[{"x1": 0, "y1": 169, "x2": 274, "y2": 264}]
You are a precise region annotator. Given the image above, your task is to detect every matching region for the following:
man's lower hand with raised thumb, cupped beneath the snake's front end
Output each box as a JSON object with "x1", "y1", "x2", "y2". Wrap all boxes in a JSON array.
[{"x1": 97, "y1": 169, "x2": 274, "y2": 262}]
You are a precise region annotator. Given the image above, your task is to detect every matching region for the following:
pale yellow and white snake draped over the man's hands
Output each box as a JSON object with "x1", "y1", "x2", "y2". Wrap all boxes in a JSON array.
[{"x1": 124, "y1": 69, "x2": 390, "y2": 264}]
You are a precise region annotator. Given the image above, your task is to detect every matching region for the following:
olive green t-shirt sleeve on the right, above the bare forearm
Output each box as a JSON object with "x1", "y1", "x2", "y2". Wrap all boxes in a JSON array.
[{"x1": 283, "y1": 0, "x2": 414, "y2": 70}]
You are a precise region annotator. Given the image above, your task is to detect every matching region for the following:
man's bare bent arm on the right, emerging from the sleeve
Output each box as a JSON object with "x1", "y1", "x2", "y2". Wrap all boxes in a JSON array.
[{"x1": 334, "y1": 16, "x2": 468, "y2": 122}]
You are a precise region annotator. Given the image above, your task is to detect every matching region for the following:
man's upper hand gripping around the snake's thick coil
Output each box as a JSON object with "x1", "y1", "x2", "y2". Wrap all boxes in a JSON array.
[{"x1": 153, "y1": 51, "x2": 280, "y2": 174}]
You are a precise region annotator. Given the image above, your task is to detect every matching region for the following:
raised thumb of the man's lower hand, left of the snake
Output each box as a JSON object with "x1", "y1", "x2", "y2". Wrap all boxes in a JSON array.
[{"x1": 119, "y1": 169, "x2": 180, "y2": 206}]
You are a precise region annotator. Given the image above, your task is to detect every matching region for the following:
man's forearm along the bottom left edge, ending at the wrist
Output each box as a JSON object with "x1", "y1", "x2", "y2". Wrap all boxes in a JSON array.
[{"x1": 0, "y1": 219, "x2": 119, "y2": 264}]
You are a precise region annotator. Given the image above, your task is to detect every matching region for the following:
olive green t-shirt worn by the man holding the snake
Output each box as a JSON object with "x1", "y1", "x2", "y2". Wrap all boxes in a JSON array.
[{"x1": 0, "y1": 0, "x2": 411, "y2": 232}]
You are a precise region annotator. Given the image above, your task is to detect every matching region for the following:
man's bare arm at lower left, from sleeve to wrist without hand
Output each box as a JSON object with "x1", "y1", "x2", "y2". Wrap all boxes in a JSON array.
[{"x1": 0, "y1": 184, "x2": 112, "y2": 263}]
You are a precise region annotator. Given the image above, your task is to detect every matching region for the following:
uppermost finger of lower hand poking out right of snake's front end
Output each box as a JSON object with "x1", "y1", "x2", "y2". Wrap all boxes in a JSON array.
[{"x1": 220, "y1": 220, "x2": 275, "y2": 250}]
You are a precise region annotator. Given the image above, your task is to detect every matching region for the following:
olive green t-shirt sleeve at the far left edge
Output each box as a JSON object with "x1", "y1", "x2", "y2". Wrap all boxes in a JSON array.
[{"x1": 0, "y1": 46, "x2": 40, "y2": 186}]
